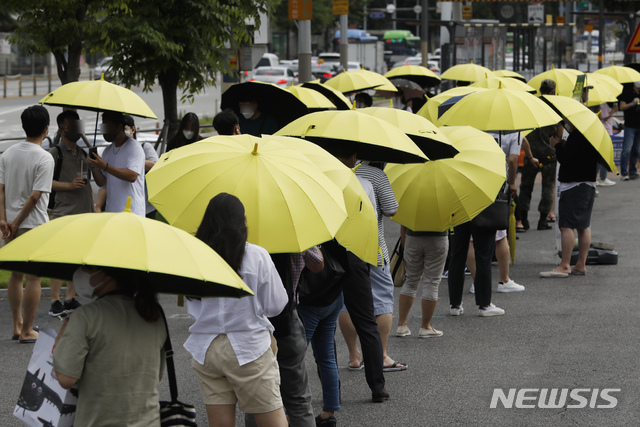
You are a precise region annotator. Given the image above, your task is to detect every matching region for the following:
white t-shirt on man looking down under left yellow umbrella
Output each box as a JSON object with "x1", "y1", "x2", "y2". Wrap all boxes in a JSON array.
[{"x1": 102, "y1": 138, "x2": 146, "y2": 216}]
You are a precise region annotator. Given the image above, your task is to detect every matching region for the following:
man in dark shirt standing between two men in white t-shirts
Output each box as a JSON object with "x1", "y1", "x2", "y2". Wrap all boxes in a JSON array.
[{"x1": 49, "y1": 110, "x2": 94, "y2": 316}]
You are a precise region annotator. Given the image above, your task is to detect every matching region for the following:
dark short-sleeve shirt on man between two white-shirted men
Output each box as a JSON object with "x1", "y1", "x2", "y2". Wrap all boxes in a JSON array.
[{"x1": 49, "y1": 142, "x2": 93, "y2": 218}]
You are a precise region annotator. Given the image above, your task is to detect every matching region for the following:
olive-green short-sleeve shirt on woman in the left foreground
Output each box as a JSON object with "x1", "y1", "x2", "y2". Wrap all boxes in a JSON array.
[{"x1": 53, "y1": 294, "x2": 167, "y2": 427}]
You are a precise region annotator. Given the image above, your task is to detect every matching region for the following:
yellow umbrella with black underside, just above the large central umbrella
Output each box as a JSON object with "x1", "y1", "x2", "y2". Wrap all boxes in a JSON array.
[{"x1": 276, "y1": 110, "x2": 427, "y2": 163}]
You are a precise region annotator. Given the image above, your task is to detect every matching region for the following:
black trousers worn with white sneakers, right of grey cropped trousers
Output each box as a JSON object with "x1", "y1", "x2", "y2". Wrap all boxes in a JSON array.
[{"x1": 448, "y1": 222, "x2": 496, "y2": 307}]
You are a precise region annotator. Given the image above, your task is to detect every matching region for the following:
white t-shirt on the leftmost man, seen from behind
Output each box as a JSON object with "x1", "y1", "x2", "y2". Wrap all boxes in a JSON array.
[{"x1": 0, "y1": 141, "x2": 54, "y2": 228}]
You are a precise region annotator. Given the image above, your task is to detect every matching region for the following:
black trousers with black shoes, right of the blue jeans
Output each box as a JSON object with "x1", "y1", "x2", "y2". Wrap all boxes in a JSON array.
[{"x1": 342, "y1": 252, "x2": 382, "y2": 391}]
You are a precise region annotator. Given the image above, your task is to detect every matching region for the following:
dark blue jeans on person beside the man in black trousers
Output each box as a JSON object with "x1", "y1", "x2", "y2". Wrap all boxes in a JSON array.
[{"x1": 298, "y1": 294, "x2": 342, "y2": 412}]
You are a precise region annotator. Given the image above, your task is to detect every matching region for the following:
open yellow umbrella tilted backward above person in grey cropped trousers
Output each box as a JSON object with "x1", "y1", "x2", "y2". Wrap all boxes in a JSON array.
[{"x1": 385, "y1": 126, "x2": 506, "y2": 231}]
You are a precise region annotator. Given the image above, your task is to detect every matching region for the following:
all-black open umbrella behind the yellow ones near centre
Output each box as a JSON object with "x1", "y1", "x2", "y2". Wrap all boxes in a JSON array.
[{"x1": 220, "y1": 82, "x2": 309, "y2": 127}]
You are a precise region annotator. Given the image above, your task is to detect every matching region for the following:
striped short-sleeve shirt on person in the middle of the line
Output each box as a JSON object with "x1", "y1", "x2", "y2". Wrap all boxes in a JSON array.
[{"x1": 356, "y1": 163, "x2": 398, "y2": 267}]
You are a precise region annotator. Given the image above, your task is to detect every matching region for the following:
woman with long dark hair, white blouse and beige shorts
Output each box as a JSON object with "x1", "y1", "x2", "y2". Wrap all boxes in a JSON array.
[{"x1": 184, "y1": 193, "x2": 287, "y2": 427}]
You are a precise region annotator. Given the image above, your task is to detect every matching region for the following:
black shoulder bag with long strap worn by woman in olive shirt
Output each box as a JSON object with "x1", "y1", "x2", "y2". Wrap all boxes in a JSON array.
[{"x1": 158, "y1": 305, "x2": 198, "y2": 427}]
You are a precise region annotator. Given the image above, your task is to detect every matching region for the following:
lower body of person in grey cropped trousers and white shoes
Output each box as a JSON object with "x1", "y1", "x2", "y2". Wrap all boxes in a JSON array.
[{"x1": 396, "y1": 226, "x2": 449, "y2": 338}]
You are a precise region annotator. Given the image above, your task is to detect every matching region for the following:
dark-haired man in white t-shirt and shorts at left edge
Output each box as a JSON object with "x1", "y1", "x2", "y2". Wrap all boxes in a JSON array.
[{"x1": 0, "y1": 105, "x2": 54, "y2": 344}]
